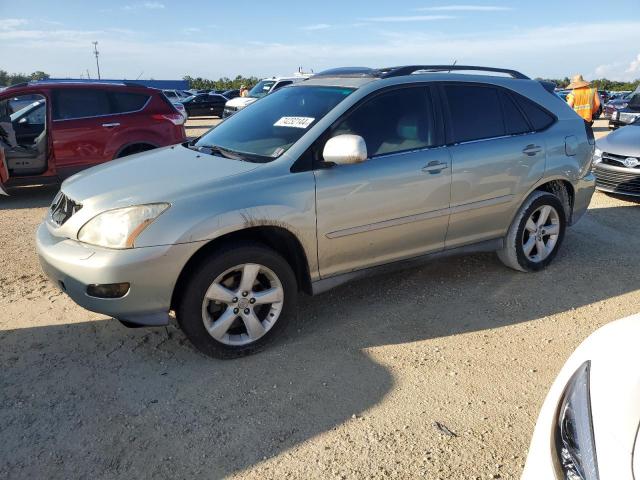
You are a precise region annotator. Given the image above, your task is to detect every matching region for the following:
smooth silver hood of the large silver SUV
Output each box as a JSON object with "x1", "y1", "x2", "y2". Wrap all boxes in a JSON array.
[{"x1": 62, "y1": 145, "x2": 259, "y2": 208}]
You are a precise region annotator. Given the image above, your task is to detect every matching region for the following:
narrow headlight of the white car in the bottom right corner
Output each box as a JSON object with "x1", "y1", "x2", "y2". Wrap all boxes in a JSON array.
[{"x1": 555, "y1": 361, "x2": 599, "y2": 480}]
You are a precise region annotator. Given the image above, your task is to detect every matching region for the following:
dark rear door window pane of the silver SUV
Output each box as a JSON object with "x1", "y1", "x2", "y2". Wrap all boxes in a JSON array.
[{"x1": 444, "y1": 85, "x2": 506, "y2": 143}]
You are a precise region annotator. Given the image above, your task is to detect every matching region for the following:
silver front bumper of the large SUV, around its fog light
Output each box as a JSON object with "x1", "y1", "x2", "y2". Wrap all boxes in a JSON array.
[{"x1": 36, "y1": 224, "x2": 202, "y2": 326}]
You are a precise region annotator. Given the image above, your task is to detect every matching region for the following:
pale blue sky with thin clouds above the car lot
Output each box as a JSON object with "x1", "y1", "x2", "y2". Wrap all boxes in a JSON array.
[{"x1": 0, "y1": 0, "x2": 640, "y2": 80}]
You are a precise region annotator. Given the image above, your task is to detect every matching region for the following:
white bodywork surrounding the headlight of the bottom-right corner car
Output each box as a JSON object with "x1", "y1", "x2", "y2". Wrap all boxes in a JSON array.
[{"x1": 522, "y1": 315, "x2": 640, "y2": 480}]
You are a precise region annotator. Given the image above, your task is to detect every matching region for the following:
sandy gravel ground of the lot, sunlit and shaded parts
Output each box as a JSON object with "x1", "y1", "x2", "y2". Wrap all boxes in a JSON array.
[{"x1": 0, "y1": 118, "x2": 640, "y2": 479}]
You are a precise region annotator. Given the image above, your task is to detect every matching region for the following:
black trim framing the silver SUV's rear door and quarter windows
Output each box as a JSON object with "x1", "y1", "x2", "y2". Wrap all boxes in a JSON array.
[{"x1": 437, "y1": 81, "x2": 558, "y2": 147}]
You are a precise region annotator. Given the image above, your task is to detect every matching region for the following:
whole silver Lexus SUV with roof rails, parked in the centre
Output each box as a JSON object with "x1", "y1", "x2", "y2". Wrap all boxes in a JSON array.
[{"x1": 37, "y1": 65, "x2": 595, "y2": 357}]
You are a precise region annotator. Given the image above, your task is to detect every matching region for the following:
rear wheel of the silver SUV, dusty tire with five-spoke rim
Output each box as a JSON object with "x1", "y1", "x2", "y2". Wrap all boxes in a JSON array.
[{"x1": 497, "y1": 191, "x2": 567, "y2": 272}]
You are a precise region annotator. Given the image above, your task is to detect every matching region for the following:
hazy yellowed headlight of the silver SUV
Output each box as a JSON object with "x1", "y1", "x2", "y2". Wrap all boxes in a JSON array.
[{"x1": 78, "y1": 203, "x2": 169, "y2": 248}]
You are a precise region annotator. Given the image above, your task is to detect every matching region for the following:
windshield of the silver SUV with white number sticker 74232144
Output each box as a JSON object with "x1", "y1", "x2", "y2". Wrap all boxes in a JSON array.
[{"x1": 195, "y1": 86, "x2": 353, "y2": 162}]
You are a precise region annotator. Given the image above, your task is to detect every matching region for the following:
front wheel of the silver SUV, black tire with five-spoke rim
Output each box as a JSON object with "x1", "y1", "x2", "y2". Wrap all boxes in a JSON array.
[{"x1": 176, "y1": 243, "x2": 298, "y2": 358}]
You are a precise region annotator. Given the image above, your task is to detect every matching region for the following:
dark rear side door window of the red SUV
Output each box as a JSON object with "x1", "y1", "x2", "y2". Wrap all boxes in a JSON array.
[{"x1": 53, "y1": 88, "x2": 111, "y2": 120}]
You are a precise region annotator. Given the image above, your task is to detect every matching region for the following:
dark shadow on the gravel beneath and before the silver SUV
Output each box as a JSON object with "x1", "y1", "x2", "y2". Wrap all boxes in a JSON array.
[{"x1": 0, "y1": 205, "x2": 640, "y2": 478}]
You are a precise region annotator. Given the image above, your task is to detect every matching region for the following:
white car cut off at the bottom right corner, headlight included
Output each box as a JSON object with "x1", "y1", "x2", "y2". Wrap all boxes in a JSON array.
[{"x1": 522, "y1": 315, "x2": 640, "y2": 480}]
